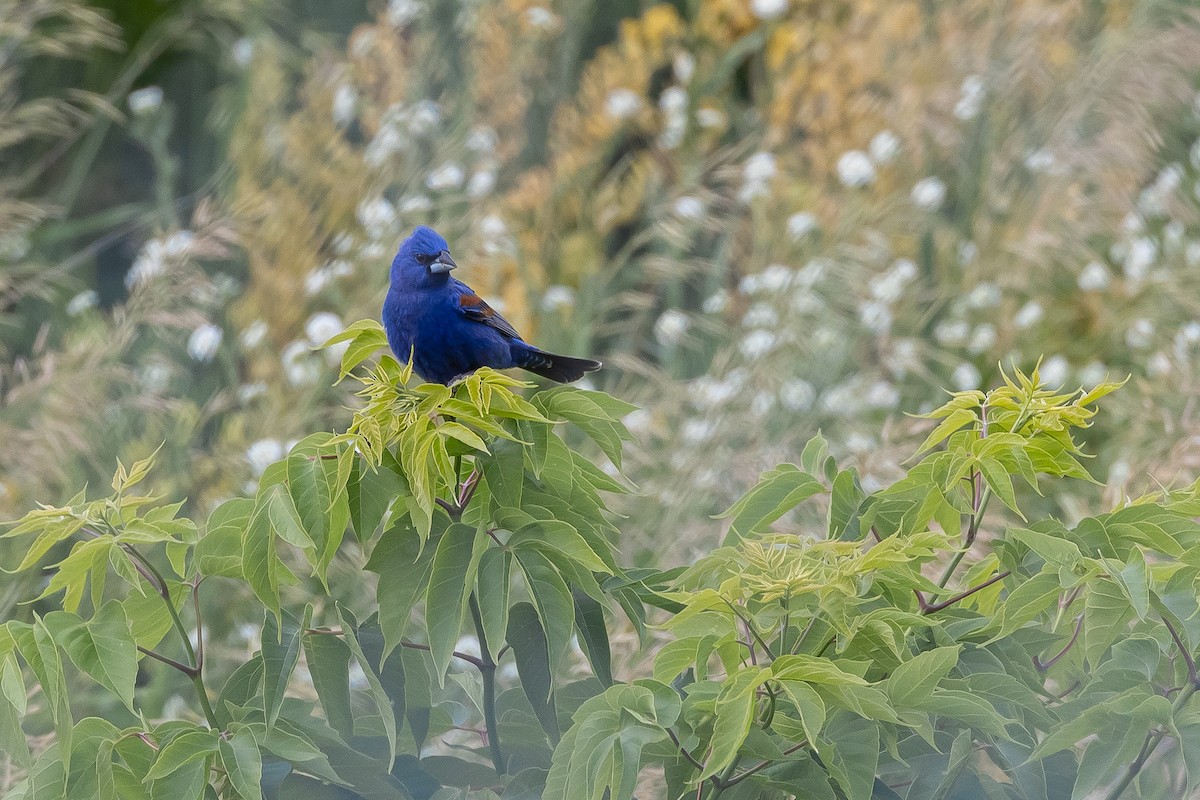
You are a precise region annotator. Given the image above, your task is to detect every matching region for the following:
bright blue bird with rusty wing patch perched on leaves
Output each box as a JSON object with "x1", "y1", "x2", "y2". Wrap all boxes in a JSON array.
[{"x1": 383, "y1": 225, "x2": 601, "y2": 385}]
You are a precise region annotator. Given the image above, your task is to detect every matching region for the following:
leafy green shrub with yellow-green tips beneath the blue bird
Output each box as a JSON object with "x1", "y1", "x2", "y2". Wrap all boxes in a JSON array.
[{"x1": 0, "y1": 333, "x2": 1200, "y2": 800}]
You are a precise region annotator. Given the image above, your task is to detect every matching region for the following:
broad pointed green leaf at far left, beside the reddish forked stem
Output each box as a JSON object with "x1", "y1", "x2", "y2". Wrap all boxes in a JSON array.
[{"x1": 58, "y1": 600, "x2": 138, "y2": 710}]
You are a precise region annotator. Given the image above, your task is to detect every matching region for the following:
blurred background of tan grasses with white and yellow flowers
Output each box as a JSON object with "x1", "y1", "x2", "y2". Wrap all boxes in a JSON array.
[{"x1": 0, "y1": 0, "x2": 1200, "y2": 666}]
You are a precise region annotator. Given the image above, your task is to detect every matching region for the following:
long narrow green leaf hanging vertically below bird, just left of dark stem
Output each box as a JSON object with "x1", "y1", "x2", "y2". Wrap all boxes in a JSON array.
[{"x1": 425, "y1": 523, "x2": 477, "y2": 685}]
